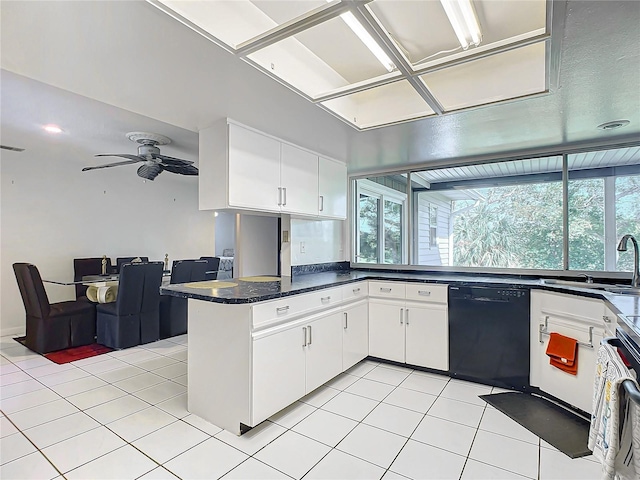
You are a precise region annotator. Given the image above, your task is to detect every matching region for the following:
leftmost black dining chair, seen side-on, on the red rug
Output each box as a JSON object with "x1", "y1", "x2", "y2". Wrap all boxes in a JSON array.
[{"x1": 13, "y1": 263, "x2": 96, "y2": 354}]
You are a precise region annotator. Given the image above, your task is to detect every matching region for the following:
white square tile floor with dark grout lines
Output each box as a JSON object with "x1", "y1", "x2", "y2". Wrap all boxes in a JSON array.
[{"x1": 0, "y1": 336, "x2": 600, "y2": 480}]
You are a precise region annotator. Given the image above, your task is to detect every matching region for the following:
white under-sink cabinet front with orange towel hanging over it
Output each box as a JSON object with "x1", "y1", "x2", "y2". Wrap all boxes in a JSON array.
[{"x1": 532, "y1": 316, "x2": 603, "y2": 412}]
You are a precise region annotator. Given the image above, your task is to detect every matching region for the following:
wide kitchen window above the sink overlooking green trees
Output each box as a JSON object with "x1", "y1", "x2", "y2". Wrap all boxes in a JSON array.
[{"x1": 358, "y1": 146, "x2": 640, "y2": 272}]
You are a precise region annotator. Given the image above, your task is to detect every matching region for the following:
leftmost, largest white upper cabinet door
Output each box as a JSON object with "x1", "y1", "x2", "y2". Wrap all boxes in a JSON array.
[{"x1": 229, "y1": 124, "x2": 280, "y2": 212}]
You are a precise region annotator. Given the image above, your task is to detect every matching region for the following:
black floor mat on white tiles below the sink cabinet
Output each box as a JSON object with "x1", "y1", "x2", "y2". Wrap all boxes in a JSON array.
[{"x1": 480, "y1": 392, "x2": 591, "y2": 458}]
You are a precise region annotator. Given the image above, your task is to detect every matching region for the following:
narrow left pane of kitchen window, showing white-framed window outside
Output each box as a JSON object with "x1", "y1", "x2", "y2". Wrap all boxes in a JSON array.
[{"x1": 356, "y1": 175, "x2": 407, "y2": 264}]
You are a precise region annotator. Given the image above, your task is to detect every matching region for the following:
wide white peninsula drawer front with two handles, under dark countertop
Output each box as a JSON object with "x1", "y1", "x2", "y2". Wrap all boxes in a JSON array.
[{"x1": 252, "y1": 287, "x2": 342, "y2": 328}]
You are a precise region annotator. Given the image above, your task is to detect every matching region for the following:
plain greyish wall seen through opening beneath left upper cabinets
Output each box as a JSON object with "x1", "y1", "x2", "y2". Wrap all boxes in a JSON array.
[{"x1": 234, "y1": 215, "x2": 279, "y2": 277}]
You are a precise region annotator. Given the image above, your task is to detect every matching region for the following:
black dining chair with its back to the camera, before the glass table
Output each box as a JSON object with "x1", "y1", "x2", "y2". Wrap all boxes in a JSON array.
[{"x1": 96, "y1": 262, "x2": 163, "y2": 349}]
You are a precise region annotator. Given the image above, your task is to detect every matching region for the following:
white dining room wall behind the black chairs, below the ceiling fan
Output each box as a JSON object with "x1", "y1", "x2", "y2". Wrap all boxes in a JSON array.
[{"x1": 0, "y1": 142, "x2": 215, "y2": 335}]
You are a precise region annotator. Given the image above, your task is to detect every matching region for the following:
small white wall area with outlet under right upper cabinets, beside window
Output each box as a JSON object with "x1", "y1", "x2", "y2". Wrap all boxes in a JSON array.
[{"x1": 291, "y1": 218, "x2": 347, "y2": 265}]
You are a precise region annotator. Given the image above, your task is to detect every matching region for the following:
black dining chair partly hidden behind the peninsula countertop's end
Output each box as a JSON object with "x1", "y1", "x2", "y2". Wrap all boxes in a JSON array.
[{"x1": 160, "y1": 260, "x2": 209, "y2": 338}]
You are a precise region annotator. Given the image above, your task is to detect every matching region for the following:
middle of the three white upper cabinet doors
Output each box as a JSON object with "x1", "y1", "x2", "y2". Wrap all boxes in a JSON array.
[{"x1": 280, "y1": 143, "x2": 318, "y2": 215}]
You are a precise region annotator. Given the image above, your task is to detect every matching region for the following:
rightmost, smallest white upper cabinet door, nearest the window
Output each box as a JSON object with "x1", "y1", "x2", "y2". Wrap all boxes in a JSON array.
[{"x1": 318, "y1": 157, "x2": 347, "y2": 219}]
